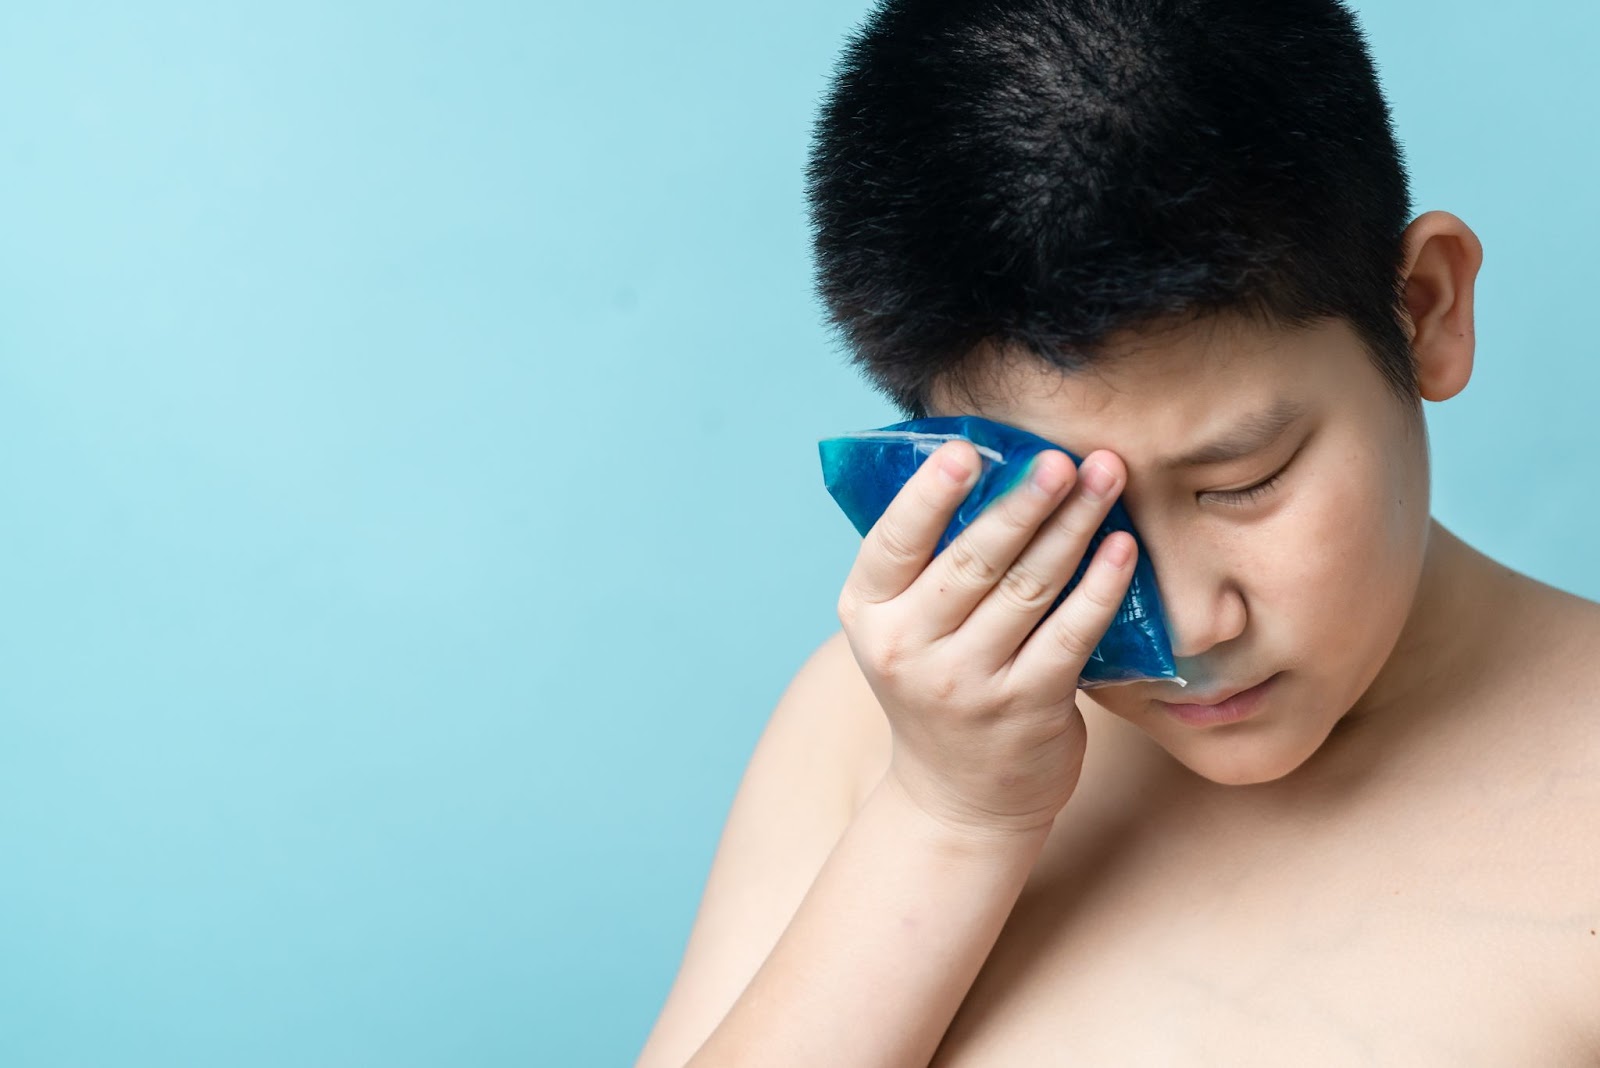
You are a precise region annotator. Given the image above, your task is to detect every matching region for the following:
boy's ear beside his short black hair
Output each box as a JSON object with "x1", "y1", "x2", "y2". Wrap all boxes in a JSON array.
[{"x1": 1403, "y1": 211, "x2": 1483, "y2": 401}]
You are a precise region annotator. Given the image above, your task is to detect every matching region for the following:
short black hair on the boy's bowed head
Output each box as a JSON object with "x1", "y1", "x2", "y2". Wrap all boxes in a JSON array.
[{"x1": 805, "y1": 0, "x2": 1419, "y2": 419}]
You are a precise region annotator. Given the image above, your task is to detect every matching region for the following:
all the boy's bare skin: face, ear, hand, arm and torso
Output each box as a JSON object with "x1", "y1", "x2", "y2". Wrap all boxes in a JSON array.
[{"x1": 638, "y1": 213, "x2": 1600, "y2": 1068}]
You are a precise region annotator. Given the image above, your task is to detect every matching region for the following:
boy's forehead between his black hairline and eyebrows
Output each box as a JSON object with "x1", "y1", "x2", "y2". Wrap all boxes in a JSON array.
[{"x1": 930, "y1": 318, "x2": 1376, "y2": 464}]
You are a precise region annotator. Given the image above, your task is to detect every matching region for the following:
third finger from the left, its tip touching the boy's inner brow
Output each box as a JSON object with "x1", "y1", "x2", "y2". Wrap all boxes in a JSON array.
[{"x1": 946, "y1": 451, "x2": 1123, "y2": 664}]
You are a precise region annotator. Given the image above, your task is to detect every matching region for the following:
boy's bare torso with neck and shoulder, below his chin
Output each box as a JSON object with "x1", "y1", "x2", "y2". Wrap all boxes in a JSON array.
[{"x1": 838, "y1": 565, "x2": 1600, "y2": 1068}]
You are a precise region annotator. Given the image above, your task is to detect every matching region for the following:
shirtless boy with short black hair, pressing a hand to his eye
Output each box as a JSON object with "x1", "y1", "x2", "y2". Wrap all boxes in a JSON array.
[{"x1": 638, "y1": 0, "x2": 1600, "y2": 1068}]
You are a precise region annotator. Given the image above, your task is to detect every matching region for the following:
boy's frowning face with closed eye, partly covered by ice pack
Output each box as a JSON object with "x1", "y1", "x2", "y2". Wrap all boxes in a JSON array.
[{"x1": 930, "y1": 318, "x2": 1430, "y2": 785}]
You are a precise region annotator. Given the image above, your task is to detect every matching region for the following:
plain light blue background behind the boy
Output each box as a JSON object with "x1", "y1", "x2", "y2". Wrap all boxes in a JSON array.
[{"x1": 0, "y1": 0, "x2": 1600, "y2": 1068}]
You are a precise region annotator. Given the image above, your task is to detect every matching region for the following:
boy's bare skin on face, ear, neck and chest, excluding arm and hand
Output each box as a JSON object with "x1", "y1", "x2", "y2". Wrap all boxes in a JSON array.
[{"x1": 889, "y1": 204, "x2": 1600, "y2": 1068}]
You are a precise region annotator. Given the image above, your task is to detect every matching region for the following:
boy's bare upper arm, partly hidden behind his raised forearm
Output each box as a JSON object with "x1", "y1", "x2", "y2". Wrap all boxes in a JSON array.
[{"x1": 637, "y1": 632, "x2": 886, "y2": 1068}]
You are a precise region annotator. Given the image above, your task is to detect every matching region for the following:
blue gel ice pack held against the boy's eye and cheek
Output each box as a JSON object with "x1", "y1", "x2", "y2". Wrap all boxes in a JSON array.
[{"x1": 818, "y1": 416, "x2": 1184, "y2": 689}]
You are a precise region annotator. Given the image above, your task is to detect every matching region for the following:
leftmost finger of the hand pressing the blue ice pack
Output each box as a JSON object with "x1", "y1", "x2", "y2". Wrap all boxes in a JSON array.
[{"x1": 838, "y1": 438, "x2": 981, "y2": 622}]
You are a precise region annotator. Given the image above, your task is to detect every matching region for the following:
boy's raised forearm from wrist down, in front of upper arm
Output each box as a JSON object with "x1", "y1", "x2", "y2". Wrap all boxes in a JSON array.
[{"x1": 688, "y1": 779, "x2": 1048, "y2": 1068}]
